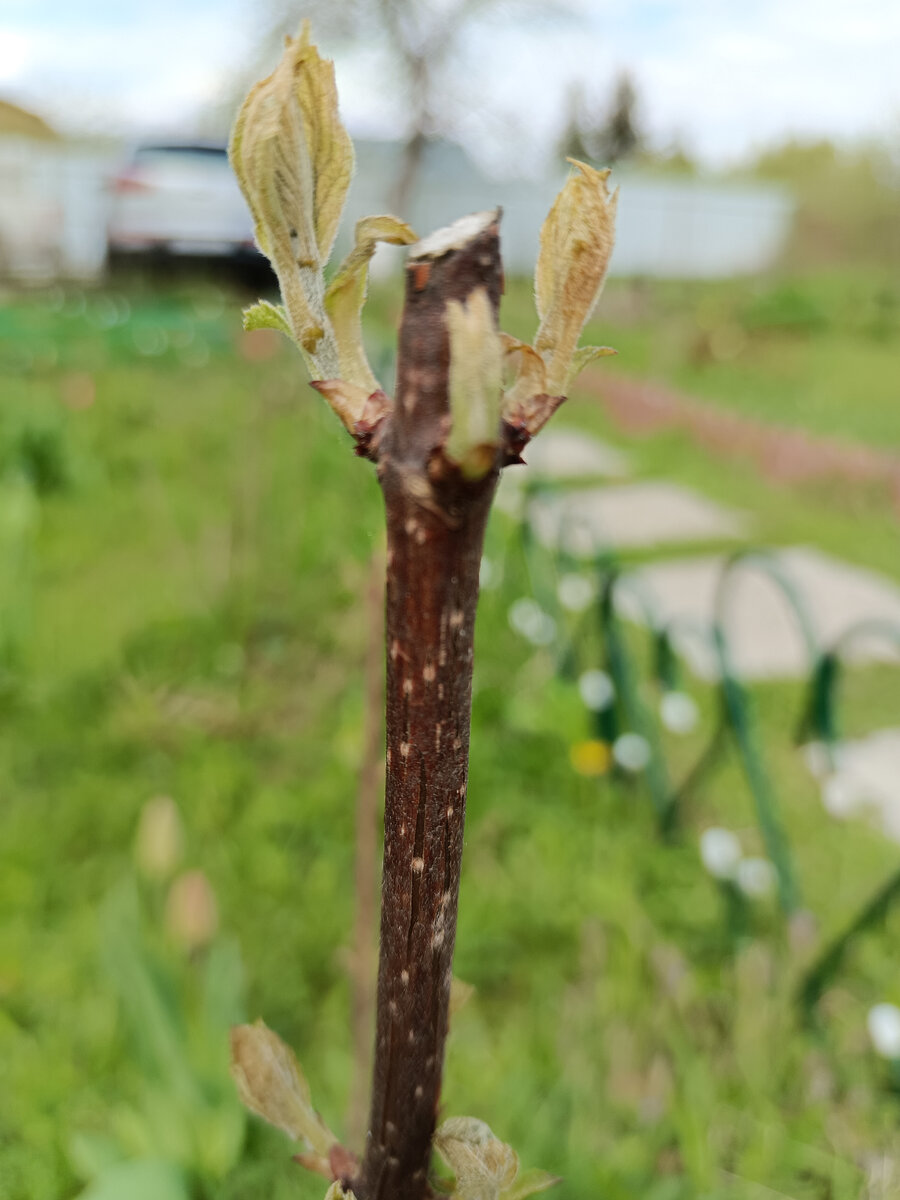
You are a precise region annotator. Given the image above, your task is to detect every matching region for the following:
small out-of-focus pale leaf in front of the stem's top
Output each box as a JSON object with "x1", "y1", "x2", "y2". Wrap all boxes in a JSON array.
[{"x1": 445, "y1": 288, "x2": 503, "y2": 479}]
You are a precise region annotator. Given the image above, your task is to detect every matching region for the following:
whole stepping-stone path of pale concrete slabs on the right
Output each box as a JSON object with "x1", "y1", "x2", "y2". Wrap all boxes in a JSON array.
[{"x1": 513, "y1": 430, "x2": 900, "y2": 841}]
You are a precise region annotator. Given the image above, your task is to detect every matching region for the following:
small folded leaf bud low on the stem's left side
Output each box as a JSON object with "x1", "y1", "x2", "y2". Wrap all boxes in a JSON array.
[{"x1": 232, "y1": 1020, "x2": 337, "y2": 1158}]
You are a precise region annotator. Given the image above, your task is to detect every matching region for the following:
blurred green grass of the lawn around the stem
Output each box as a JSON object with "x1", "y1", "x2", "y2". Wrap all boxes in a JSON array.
[{"x1": 0, "y1": 274, "x2": 900, "y2": 1200}]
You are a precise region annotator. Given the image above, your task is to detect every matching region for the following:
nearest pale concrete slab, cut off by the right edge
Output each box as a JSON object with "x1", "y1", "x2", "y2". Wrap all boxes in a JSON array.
[{"x1": 804, "y1": 728, "x2": 900, "y2": 842}]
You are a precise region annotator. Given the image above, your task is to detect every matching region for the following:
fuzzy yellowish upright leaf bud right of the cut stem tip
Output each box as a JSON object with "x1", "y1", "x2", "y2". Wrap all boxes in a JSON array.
[{"x1": 534, "y1": 158, "x2": 618, "y2": 395}]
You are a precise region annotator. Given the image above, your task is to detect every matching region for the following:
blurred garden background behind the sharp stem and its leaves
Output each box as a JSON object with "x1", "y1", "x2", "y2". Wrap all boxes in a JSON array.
[{"x1": 0, "y1": 0, "x2": 900, "y2": 1200}]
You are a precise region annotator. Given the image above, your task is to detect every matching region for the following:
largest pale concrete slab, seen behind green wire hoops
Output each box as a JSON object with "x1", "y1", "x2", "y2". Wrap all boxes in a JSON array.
[{"x1": 619, "y1": 546, "x2": 900, "y2": 679}]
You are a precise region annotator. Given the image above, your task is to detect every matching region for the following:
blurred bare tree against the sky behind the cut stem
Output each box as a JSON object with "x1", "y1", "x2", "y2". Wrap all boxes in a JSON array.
[{"x1": 254, "y1": 0, "x2": 571, "y2": 217}]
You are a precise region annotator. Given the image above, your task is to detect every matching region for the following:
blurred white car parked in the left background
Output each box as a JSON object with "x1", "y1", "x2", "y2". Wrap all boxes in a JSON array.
[{"x1": 108, "y1": 143, "x2": 256, "y2": 257}]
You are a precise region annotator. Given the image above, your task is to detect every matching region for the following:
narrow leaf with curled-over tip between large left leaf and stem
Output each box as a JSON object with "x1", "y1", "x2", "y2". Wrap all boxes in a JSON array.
[{"x1": 325, "y1": 216, "x2": 415, "y2": 395}]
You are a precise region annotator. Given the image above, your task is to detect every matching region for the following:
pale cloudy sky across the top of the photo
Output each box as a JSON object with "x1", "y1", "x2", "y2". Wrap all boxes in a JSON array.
[{"x1": 0, "y1": 0, "x2": 900, "y2": 167}]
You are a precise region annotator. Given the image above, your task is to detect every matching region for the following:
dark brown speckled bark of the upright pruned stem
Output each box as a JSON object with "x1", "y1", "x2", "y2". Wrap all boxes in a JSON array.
[{"x1": 352, "y1": 221, "x2": 504, "y2": 1200}]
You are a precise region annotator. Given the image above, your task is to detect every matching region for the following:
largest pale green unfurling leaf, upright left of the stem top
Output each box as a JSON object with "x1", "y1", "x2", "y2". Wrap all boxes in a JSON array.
[{"x1": 229, "y1": 24, "x2": 354, "y2": 378}]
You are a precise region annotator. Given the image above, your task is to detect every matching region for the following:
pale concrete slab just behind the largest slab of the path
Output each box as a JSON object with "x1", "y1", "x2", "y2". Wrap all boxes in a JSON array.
[{"x1": 529, "y1": 480, "x2": 748, "y2": 554}]
